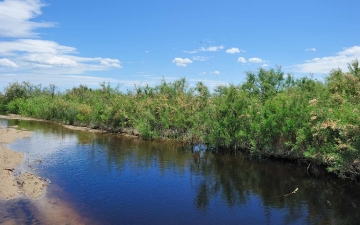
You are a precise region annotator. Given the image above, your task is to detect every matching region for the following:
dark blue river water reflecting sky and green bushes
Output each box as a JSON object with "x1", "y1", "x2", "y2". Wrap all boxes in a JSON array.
[{"x1": 0, "y1": 120, "x2": 360, "y2": 224}]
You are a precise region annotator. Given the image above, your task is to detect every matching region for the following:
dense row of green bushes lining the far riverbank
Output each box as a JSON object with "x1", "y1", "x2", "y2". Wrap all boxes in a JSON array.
[{"x1": 0, "y1": 60, "x2": 360, "y2": 177}]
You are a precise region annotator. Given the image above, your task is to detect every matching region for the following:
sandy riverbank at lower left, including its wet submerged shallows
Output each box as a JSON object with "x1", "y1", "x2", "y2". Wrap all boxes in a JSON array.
[{"x1": 0, "y1": 120, "x2": 95, "y2": 225}]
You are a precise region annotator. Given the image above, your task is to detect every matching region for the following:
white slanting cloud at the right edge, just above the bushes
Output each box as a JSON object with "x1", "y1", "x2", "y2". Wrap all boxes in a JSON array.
[{"x1": 295, "y1": 46, "x2": 360, "y2": 73}]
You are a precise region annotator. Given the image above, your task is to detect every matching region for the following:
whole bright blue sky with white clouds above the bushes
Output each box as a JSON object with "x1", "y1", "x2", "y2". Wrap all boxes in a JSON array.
[{"x1": 0, "y1": 0, "x2": 360, "y2": 91}]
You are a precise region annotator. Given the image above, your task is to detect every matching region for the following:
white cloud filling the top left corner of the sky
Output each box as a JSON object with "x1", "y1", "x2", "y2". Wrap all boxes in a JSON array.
[{"x1": 0, "y1": 0, "x2": 54, "y2": 38}]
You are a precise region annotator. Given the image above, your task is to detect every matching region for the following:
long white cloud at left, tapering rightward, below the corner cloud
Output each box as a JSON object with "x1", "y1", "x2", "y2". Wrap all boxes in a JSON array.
[{"x1": 0, "y1": 39, "x2": 122, "y2": 74}]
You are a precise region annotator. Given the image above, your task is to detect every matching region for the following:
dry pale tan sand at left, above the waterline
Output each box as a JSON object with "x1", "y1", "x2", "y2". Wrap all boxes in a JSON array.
[{"x1": 0, "y1": 128, "x2": 47, "y2": 199}]
